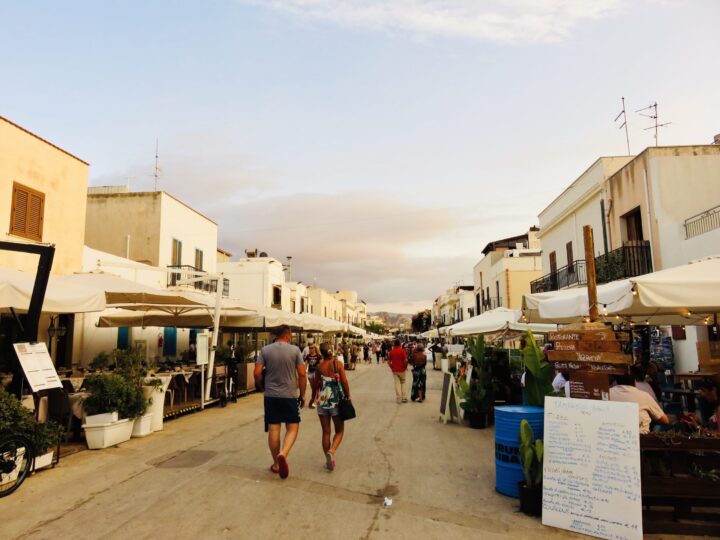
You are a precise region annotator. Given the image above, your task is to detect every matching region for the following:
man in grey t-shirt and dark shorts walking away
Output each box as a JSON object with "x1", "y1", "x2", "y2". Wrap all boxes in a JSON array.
[{"x1": 254, "y1": 325, "x2": 307, "y2": 479}]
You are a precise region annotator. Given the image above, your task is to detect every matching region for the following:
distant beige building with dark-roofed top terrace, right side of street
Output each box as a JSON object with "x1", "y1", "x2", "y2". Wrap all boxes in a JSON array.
[{"x1": 473, "y1": 227, "x2": 542, "y2": 315}]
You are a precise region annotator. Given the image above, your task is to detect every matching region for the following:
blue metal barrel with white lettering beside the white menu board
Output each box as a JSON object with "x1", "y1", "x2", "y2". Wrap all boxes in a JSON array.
[{"x1": 495, "y1": 405, "x2": 545, "y2": 498}]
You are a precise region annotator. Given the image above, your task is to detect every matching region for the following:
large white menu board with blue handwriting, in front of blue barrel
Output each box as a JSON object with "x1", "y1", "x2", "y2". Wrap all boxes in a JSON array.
[{"x1": 542, "y1": 397, "x2": 642, "y2": 540}]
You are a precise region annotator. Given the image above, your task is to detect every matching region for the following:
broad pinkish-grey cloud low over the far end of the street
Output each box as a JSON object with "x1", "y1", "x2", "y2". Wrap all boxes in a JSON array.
[{"x1": 212, "y1": 192, "x2": 476, "y2": 311}]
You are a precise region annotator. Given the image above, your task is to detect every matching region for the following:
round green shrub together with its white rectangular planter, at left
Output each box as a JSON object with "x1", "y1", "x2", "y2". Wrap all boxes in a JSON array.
[{"x1": 83, "y1": 374, "x2": 147, "y2": 450}]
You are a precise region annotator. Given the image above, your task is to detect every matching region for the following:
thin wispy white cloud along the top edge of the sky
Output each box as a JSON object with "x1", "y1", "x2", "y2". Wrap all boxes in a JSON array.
[{"x1": 242, "y1": 0, "x2": 620, "y2": 44}]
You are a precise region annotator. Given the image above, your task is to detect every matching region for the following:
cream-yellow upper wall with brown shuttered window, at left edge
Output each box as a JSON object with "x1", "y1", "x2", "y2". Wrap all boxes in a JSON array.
[{"x1": 0, "y1": 117, "x2": 89, "y2": 274}]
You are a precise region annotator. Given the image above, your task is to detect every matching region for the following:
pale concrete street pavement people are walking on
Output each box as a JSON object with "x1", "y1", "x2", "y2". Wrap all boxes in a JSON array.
[{"x1": 0, "y1": 365, "x2": 696, "y2": 539}]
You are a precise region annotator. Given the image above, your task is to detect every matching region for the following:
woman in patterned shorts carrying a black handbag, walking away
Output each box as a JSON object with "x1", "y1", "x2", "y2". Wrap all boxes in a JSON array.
[{"x1": 315, "y1": 343, "x2": 350, "y2": 471}]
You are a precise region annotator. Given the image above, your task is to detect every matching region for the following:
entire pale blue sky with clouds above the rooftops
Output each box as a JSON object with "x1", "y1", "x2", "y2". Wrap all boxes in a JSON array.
[{"x1": 0, "y1": 0, "x2": 720, "y2": 313}]
